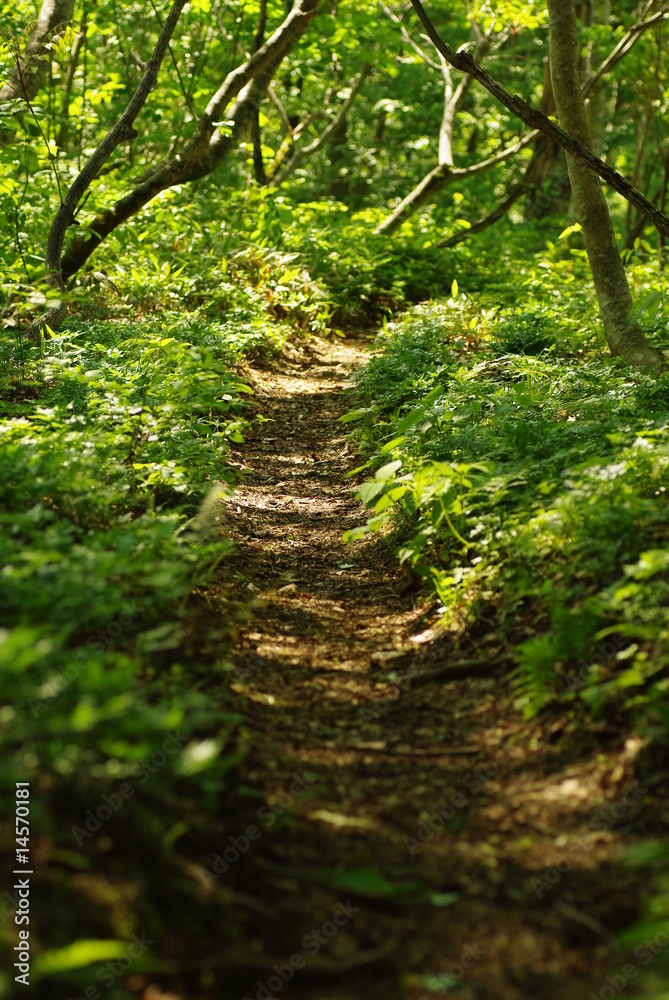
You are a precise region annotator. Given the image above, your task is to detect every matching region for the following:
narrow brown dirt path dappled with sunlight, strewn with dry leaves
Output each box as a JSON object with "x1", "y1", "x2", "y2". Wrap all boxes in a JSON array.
[{"x1": 214, "y1": 338, "x2": 639, "y2": 1000}]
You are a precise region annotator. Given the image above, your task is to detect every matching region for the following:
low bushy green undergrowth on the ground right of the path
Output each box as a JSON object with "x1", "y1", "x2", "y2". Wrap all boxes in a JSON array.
[{"x1": 347, "y1": 286, "x2": 669, "y2": 732}]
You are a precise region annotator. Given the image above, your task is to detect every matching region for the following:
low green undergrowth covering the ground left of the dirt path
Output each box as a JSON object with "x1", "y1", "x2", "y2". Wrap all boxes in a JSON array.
[{"x1": 0, "y1": 302, "x2": 274, "y2": 995}]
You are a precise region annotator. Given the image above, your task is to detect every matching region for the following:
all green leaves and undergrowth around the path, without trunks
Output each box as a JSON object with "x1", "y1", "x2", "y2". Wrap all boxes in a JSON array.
[{"x1": 0, "y1": 0, "x2": 669, "y2": 984}]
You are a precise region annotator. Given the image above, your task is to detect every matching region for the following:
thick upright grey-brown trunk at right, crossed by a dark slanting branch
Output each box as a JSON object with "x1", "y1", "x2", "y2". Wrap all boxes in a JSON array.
[{"x1": 548, "y1": 0, "x2": 663, "y2": 370}]
